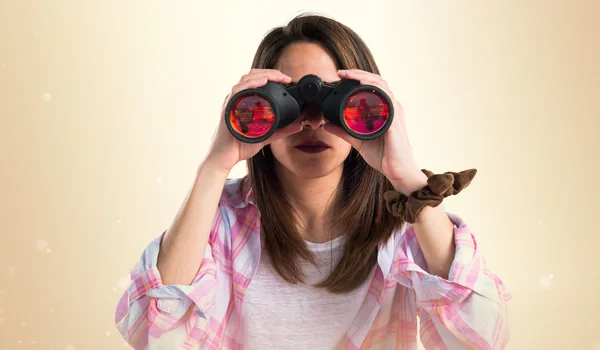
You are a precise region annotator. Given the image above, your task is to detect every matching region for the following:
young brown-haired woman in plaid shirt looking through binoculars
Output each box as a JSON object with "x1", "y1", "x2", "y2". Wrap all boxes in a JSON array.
[{"x1": 116, "y1": 15, "x2": 510, "y2": 349}]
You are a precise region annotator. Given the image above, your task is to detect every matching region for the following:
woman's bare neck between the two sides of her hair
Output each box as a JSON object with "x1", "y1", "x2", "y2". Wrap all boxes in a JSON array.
[{"x1": 276, "y1": 162, "x2": 343, "y2": 243}]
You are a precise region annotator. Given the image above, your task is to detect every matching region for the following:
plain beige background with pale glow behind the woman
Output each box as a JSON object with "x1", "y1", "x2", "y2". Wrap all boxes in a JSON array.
[{"x1": 0, "y1": 0, "x2": 600, "y2": 350}]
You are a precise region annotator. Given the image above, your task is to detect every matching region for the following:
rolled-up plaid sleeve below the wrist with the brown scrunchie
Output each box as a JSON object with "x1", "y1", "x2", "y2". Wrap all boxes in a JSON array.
[{"x1": 393, "y1": 213, "x2": 511, "y2": 349}]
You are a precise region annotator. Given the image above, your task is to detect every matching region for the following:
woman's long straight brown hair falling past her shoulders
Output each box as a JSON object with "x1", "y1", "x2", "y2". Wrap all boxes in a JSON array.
[{"x1": 240, "y1": 14, "x2": 402, "y2": 293}]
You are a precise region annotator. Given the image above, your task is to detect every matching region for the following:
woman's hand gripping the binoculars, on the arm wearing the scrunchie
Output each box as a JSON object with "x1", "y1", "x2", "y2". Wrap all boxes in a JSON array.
[{"x1": 323, "y1": 69, "x2": 427, "y2": 195}]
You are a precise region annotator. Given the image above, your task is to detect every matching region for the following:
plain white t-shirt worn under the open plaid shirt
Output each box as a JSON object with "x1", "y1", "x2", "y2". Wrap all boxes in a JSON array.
[{"x1": 243, "y1": 236, "x2": 375, "y2": 350}]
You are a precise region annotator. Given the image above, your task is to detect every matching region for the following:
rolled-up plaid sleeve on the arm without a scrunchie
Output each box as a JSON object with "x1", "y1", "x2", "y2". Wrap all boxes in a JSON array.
[{"x1": 115, "y1": 213, "x2": 223, "y2": 349}]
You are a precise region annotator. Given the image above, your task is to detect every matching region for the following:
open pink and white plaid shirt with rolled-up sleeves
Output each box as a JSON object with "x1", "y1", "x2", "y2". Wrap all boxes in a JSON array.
[{"x1": 115, "y1": 179, "x2": 510, "y2": 349}]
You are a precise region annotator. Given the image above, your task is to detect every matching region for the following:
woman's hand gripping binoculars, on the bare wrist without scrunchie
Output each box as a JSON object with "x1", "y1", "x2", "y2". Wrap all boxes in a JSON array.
[{"x1": 205, "y1": 69, "x2": 302, "y2": 172}]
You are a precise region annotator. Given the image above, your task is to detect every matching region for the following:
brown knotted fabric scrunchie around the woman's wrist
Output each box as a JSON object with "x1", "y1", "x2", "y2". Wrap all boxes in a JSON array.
[{"x1": 383, "y1": 169, "x2": 477, "y2": 224}]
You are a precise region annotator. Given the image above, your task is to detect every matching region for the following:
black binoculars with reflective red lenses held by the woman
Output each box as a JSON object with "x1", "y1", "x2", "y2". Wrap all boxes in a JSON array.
[{"x1": 225, "y1": 74, "x2": 394, "y2": 143}]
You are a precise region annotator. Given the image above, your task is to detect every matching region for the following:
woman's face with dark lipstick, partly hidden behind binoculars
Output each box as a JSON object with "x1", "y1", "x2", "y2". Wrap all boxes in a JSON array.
[{"x1": 271, "y1": 43, "x2": 351, "y2": 178}]
